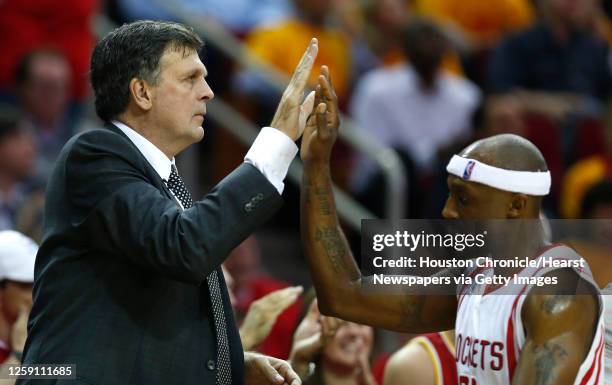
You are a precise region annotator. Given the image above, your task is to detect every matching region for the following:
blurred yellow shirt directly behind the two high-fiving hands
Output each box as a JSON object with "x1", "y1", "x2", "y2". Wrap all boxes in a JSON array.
[{"x1": 246, "y1": 20, "x2": 351, "y2": 99}]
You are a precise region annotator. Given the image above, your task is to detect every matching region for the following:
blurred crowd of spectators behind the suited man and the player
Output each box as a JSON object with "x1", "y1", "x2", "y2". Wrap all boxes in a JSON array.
[{"x1": 0, "y1": 0, "x2": 612, "y2": 384}]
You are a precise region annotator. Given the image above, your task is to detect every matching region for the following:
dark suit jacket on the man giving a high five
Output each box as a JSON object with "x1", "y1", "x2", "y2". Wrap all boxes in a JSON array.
[{"x1": 18, "y1": 125, "x2": 282, "y2": 385}]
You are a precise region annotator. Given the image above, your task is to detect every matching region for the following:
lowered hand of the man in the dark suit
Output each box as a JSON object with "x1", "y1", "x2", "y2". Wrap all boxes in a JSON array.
[{"x1": 244, "y1": 352, "x2": 302, "y2": 385}]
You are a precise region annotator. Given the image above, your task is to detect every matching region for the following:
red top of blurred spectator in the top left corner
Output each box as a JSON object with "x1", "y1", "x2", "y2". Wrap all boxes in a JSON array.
[{"x1": 0, "y1": 0, "x2": 99, "y2": 101}]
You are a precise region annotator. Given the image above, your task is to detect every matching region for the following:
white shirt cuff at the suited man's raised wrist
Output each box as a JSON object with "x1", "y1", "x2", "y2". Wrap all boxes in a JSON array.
[{"x1": 244, "y1": 127, "x2": 298, "y2": 194}]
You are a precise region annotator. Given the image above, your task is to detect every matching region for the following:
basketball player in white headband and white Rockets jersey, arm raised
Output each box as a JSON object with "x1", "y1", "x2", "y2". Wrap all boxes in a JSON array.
[{"x1": 301, "y1": 69, "x2": 604, "y2": 385}]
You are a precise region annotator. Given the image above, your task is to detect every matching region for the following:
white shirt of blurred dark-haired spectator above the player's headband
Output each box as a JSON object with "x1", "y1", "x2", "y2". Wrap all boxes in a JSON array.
[{"x1": 351, "y1": 64, "x2": 480, "y2": 188}]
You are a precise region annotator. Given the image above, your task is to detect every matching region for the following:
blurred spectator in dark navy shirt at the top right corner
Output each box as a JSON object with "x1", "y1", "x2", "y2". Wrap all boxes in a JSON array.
[{"x1": 489, "y1": 0, "x2": 611, "y2": 100}]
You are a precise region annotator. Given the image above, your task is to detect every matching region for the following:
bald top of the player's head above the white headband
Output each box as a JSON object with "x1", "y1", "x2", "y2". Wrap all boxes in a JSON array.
[{"x1": 459, "y1": 134, "x2": 548, "y2": 171}]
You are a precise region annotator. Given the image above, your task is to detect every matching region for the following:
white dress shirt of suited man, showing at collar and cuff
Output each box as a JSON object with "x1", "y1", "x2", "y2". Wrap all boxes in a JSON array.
[{"x1": 111, "y1": 120, "x2": 298, "y2": 198}]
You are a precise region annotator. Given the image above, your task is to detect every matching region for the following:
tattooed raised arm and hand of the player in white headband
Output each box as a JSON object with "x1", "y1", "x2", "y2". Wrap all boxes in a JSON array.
[{"x1": 301, "y1": 66, "x2": 457, "y2": 332}]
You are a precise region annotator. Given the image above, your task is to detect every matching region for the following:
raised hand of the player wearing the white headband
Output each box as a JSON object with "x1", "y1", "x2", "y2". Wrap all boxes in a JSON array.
[{"x1": 300, "y1": 66, "x2": 340, "y2": 164}]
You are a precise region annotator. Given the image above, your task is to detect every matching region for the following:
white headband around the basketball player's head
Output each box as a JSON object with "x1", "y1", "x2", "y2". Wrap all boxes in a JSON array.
[{"x1": 446, "y1": 155, "x2": 550, "y2": 196}]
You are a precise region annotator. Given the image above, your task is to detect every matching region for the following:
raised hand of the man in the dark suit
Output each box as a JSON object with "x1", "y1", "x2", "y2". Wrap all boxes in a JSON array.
[{"x1": 270, "y1": 39, "x2": 319, "y2": 141}]
